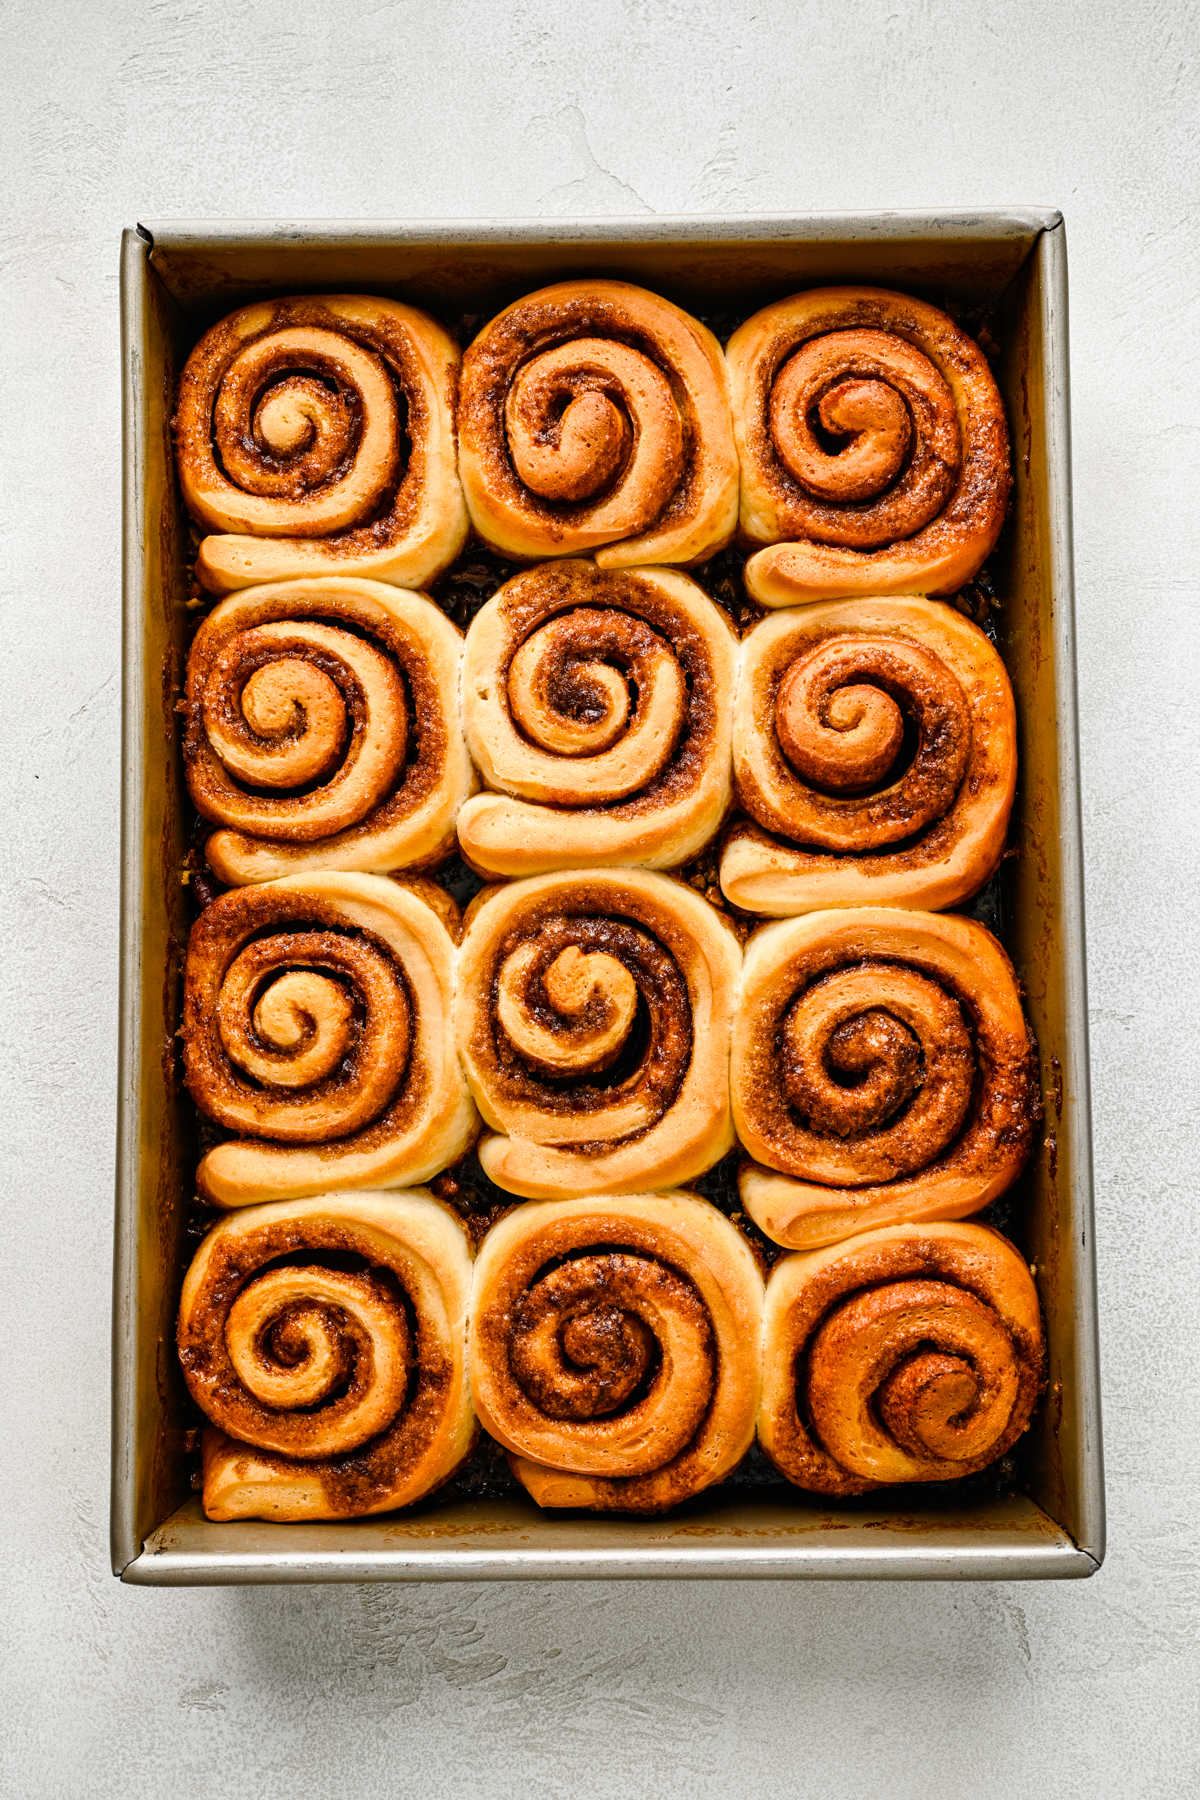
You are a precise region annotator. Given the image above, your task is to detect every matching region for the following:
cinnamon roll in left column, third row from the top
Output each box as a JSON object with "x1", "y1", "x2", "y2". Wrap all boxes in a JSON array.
[{"x1": 184, "y1": 875, "x2": 475, "y2": 1206}]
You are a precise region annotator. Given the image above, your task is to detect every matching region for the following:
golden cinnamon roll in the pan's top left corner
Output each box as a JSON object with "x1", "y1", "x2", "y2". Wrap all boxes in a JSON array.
[{"x1": 175, "y1": 293, "x2": 468, "y2": 594}]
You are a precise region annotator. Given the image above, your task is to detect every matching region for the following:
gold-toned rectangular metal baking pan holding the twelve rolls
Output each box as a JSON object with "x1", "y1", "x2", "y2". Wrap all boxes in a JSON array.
[{"x1": 112, "y1": 211, "x2": 1105, "y2": 1586}]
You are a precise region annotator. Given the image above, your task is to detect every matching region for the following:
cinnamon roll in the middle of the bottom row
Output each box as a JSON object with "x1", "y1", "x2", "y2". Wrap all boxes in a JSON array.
[{"x1": 468, "y1": 1193, "x2": 763, "y2": 1514}]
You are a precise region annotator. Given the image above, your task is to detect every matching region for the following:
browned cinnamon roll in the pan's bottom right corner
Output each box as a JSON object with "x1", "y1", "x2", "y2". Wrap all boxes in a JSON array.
[{"x1": 759, "y1": 1224, "x2": 1043, "y2": 1494}]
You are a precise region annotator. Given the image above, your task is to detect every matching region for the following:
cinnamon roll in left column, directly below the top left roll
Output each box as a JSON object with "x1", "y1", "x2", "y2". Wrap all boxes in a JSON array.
[{"x1": 184, "y1": 578, "x2": 473, "y2": 884}]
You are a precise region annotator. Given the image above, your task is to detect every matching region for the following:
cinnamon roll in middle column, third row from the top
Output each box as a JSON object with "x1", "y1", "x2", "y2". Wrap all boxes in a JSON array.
[{"x1": 457, "y1": 869, "x2": 739, "y2": 1199}]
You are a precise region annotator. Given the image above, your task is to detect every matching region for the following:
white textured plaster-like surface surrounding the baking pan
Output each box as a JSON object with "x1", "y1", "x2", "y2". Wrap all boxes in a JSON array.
[{"x1": 0, "y1": 0, "x2": 1200, "y2": 1800}]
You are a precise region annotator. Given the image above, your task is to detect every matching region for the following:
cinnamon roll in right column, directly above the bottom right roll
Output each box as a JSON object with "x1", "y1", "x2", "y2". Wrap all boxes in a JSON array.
[{"x1": 730, "y1": 907, "x2": 1040, "y2": 1249}]
